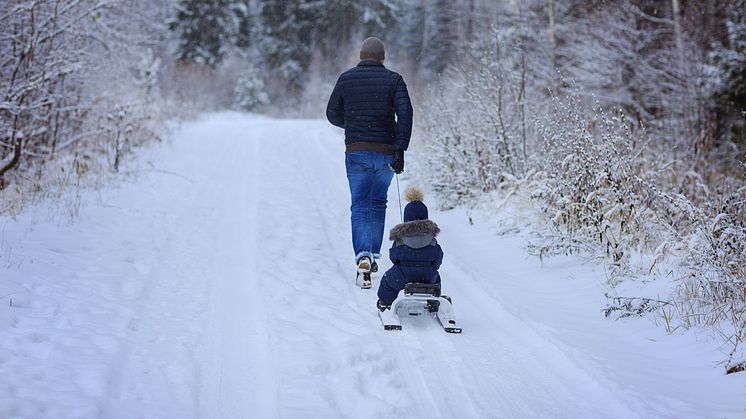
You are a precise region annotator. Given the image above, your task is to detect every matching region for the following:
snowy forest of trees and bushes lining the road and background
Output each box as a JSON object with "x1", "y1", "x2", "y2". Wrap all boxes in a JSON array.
[{"x1": 0, "y1": 0, "x2": 746, "y2": 372}]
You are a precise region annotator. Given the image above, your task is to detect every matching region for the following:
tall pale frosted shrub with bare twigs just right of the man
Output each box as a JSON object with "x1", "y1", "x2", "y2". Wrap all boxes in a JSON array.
[{"x1": 423, "y1": 29, "x2": 530, "y2": 206}]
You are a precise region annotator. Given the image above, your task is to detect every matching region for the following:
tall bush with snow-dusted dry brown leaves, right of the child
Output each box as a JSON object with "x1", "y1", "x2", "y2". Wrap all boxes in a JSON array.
[{"x1": 528, "y1": 95, "x2": 650, "y2": 271}]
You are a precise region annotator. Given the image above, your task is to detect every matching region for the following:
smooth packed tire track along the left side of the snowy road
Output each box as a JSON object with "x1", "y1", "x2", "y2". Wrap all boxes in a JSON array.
[{"x1": 201, "y1": 123, "x2": 276, "y2": 418}]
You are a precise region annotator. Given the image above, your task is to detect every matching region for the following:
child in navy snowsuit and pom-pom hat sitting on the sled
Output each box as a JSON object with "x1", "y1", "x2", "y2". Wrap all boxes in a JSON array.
[{"x1": 377, "y1": 187, "x2": 443, "y2": 312}]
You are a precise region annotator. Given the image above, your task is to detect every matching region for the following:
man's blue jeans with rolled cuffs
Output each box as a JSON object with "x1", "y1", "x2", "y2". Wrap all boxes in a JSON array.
[{"x1": 345, "y1": 151, "x2": 394, "y2": 261}]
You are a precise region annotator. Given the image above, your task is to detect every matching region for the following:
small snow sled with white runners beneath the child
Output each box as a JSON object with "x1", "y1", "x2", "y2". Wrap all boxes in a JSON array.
[{"x1": 378, "y1": 282, "x2": 461, "y2": 333}]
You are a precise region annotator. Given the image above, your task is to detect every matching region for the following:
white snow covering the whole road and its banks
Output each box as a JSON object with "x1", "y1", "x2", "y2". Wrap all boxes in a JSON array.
[{"x1": 0, "y1": 113, "x2": 746, "y2": 418}]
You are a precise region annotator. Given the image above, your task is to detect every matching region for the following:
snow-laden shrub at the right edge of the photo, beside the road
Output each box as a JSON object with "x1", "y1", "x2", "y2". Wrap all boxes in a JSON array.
[{"x1": 636, "y1": 172, "x2": 746, "y2": 370}]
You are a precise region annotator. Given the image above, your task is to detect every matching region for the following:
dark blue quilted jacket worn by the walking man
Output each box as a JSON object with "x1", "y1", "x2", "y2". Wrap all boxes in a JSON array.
[{"x1": 326, "y1": 60, "x2": 412, "y2": 151}]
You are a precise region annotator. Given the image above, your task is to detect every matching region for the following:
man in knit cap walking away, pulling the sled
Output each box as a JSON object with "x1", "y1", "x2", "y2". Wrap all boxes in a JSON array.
[{"x1": 326, "y1": 37, "x2": 412, "y2": 288}]
